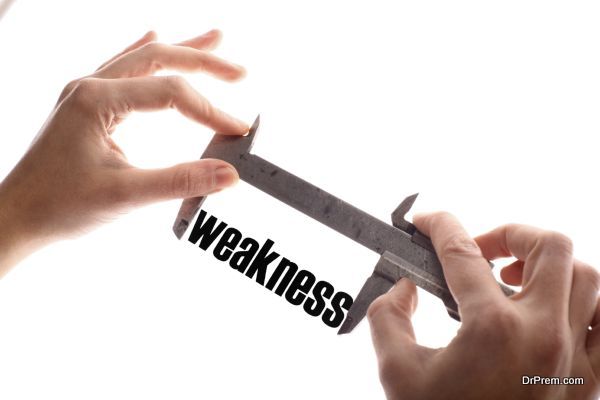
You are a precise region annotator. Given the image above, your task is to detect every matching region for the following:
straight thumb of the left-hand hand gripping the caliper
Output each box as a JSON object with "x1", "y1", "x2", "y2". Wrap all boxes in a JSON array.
[{"x1": 128, "y1": 159, "x2": 239, "y2": 203}]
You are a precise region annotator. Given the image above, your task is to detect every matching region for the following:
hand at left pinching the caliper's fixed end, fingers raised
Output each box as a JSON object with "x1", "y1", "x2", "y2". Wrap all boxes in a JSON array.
[{"x1": 0, "y1": 30, "x2": 248, "y2": 276}]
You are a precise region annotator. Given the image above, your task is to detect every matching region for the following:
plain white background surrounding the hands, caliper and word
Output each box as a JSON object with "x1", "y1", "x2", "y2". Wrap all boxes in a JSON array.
[{"x1": 0, "y1": 0, "x2": 600, "y2": 399}]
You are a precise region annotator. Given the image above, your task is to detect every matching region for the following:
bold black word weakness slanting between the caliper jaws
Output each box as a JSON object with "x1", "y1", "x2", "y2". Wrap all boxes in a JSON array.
[{"x1": 188, "y1": 210, "x2": 353, "y2": 328}]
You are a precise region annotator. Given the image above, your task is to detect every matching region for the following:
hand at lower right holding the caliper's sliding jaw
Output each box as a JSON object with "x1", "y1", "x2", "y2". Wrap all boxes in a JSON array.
[{"x1": 368, "y1": 213, "x2": 600, "y2": 400}]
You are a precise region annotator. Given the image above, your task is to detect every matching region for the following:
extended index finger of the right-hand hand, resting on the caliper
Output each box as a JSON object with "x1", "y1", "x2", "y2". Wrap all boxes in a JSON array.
[{"x1": 413, "y1": 212, "x2": 505, "y2": 314}]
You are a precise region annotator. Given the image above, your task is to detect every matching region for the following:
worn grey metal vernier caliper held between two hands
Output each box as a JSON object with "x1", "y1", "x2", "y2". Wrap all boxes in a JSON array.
[{"x1": 173, "y1": 117, "x2": 514, "y2": 334}]
